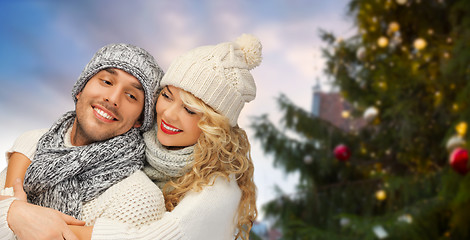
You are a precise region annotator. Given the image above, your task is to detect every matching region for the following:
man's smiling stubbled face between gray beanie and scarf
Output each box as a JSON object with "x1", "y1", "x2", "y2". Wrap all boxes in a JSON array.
[{"x1": 71, "y1": 68, "x2": 145, "y2": 146}]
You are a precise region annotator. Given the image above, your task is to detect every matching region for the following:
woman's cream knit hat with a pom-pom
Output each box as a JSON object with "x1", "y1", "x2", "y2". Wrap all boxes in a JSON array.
[{"x1": 160, "y1": 34, "x2": 262, "y2": 126}]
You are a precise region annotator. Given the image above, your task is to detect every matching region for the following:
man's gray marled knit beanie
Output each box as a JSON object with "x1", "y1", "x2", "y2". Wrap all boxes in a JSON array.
[{"x1": 72, "y1": 43, "x2": 163, "y2": 131}]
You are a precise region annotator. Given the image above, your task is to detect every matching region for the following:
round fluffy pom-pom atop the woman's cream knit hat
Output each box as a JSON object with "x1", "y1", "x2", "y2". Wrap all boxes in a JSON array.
[{"x1": 235, "y1": 34, "x2": 262, "y2": 70}]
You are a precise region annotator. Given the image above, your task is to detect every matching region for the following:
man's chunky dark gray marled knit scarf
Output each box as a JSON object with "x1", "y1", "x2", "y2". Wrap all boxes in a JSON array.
[{"x1": 24, "y1": 111, "x2": 145, "y2": 219}]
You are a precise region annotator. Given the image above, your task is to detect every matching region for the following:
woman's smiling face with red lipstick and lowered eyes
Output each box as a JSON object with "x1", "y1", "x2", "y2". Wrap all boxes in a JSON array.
[{"x1": 156, "y1": 86, "x2": 202, "y2": 147}]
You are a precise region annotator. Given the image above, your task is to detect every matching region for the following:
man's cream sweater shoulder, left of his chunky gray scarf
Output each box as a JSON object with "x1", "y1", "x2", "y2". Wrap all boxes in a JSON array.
[{"x1": 5, "y1": 128, "x2": 48, "y2": 162}]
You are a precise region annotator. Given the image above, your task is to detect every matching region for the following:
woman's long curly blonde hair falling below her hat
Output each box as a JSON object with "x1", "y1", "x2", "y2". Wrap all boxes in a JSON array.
[{"x1": 163, "y1": 91, "x2": 258, "y2": 239}]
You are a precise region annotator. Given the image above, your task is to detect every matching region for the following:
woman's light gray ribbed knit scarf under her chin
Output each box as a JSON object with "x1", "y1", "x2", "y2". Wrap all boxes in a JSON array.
[{"x1": 143, "y1": 127, "x2": 194, "y2": 189}]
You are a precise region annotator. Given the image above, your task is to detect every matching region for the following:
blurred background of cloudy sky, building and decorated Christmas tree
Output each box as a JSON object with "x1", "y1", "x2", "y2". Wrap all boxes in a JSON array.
[{"x1": 0, "y1": 0, "x2": 470, "y2": 239}]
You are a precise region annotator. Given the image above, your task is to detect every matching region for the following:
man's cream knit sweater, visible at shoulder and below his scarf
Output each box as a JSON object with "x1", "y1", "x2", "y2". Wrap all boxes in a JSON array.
[{"x1": 0, "y1": 129, "x2": 165, "y2": 238}]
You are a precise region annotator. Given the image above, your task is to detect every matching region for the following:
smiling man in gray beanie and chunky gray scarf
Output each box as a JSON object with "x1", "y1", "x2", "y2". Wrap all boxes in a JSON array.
[{"x1": 0, "y1": 44, "x2": 164, "y2": 239}]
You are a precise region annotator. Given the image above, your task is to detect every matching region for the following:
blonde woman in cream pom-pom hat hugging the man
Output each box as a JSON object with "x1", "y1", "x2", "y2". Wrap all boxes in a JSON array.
[{"x1": 2, "y1": 35, "x2": 261, "y2": 239}]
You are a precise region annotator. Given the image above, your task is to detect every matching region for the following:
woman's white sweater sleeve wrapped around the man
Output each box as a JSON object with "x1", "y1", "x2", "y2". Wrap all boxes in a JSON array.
[{"x1": 92, "y1": 174, "x2": 241, "y2": 240}]
